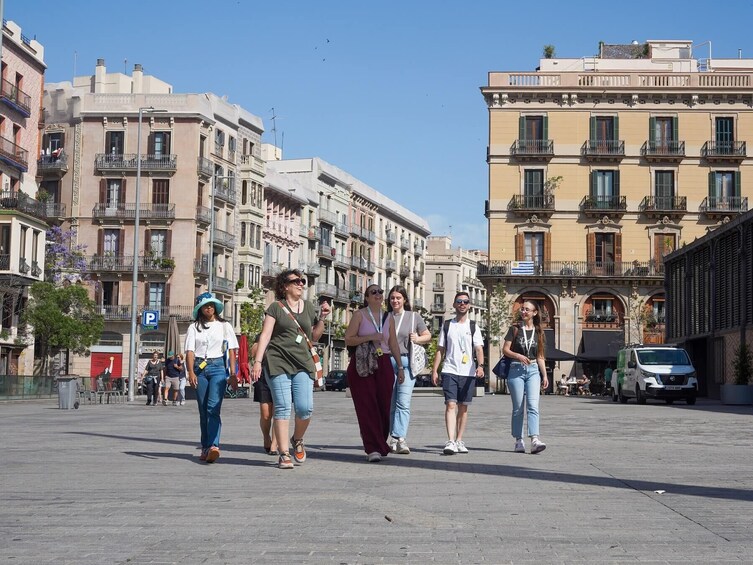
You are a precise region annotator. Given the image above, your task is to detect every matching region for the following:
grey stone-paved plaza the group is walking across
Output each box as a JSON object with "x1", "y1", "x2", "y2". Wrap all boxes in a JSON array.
[{"x1": 0, "y1": 392, "x2": 753, "y2": 565}]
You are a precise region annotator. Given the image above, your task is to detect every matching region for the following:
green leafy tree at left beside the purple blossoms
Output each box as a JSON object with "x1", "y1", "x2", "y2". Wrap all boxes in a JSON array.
[{"x1": 19, "y1": 282, "x2": 105, "y2": 375}]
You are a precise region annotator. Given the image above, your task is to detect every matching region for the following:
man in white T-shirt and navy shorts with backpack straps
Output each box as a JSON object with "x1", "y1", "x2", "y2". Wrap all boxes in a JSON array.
[{"x1": 431, "y1": 291, "x2": 484, "y2": 455}]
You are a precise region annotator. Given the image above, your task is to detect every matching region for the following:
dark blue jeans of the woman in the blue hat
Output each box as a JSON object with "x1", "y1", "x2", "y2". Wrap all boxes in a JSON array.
[{"x1": 193, "y1": 357, "x2": 227, "y2": 449}]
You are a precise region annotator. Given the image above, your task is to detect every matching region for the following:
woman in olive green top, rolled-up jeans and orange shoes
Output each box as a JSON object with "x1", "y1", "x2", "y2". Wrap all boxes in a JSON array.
[{"x1": 251, "y1": 269, "x2": 330, "y2": 469}]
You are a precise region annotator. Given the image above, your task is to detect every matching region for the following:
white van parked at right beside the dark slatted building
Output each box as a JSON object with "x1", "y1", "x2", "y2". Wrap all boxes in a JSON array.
[{"x1": 612, "y1": 345, "x2": 698, "y2": 404}]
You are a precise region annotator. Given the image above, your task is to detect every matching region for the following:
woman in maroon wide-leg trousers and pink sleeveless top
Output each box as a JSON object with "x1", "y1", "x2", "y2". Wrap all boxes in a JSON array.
[{"x1": 345, "y1": 284, "x2": 405, "y2": 463}]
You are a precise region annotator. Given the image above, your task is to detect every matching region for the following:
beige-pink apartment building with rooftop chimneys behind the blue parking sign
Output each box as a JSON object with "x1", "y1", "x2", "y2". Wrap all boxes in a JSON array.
[{"x1": 43, "y1": 59, "x2": 264, "y2": 377}]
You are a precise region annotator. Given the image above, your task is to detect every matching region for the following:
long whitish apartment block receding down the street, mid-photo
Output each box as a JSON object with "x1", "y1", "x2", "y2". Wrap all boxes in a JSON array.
[{"x1": 264, "y1": 154, "x2": 429, "y2": 369}]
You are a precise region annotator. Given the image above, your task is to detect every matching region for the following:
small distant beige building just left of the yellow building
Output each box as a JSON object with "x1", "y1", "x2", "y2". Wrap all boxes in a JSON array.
[{"x1": 426, "y1": 235, "x2": 487, "y2": 333}]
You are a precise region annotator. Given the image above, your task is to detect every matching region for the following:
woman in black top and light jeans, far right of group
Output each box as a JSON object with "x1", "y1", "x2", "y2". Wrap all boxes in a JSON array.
[{"x1": 502, "y1": 300, "x2": 549, "y2": 453}]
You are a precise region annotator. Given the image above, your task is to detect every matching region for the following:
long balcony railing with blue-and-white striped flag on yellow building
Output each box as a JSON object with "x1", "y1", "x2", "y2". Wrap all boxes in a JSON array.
[{"x1": 478, "y1": 261, "x2": 664, "y2": 279}]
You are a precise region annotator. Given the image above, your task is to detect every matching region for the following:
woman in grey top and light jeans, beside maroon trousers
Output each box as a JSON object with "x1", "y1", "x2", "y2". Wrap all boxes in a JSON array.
[{"x1": 387, "y1": 285, "x2": 431, "y2": 455}]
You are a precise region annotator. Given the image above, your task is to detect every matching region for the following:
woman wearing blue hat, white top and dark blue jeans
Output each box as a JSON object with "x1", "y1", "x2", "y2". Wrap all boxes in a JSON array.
[{"x1": 185, "y1": 292, "x2": 238, "y2": 463}]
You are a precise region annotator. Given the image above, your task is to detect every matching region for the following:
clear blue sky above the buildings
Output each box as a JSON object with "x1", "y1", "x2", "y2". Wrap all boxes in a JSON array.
[{"x1": 10, "y1": 0, "x2": 753, "y2": 249}]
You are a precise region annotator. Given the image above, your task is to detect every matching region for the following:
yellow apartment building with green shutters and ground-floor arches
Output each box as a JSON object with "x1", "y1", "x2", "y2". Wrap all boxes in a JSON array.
[{"x1": 479, "y1": 40, "x2": 753, "y2": 388}]
